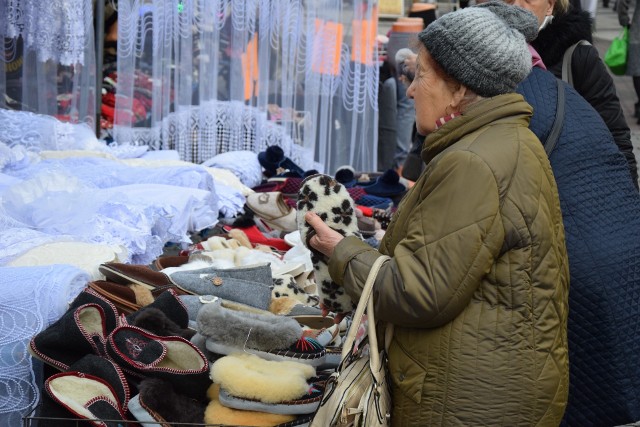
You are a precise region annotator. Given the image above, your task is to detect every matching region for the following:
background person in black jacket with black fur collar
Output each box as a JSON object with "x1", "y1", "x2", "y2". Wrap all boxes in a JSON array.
[{"x1": 507, "y1": 0, "x2": 638, "y2": 189}]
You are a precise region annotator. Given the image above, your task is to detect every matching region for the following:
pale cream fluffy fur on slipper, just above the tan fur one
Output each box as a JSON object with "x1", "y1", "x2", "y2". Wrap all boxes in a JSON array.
[{"x1": 211, "y1": 353, "x2": 316, "y2": 403}]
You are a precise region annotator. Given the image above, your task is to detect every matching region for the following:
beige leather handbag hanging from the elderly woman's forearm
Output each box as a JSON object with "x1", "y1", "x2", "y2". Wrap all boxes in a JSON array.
[{"x1": 310, "y1": 255, "x2": 393, "y2": 427}]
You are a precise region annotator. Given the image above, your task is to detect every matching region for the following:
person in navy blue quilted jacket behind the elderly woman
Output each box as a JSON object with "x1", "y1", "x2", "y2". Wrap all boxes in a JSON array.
[{"x1": 480, "y1": 2, "x2": 640, "y2": 427}]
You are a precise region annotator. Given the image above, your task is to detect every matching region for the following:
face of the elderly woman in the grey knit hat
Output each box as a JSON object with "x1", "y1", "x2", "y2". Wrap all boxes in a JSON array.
[{"x1": 407, "y1": 49, "x2": 453, "y2": 135}]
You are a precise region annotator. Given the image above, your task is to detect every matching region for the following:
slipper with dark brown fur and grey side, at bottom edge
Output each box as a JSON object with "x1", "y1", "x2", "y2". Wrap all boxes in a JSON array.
[{"x1": 129, "y1": 378, "x2": 206, "y2": 427}]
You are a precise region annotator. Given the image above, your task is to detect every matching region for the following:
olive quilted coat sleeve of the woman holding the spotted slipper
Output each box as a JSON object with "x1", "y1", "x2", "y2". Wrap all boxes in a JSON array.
[{"x1": 329, "y1": 151, "x2": 504, "y2": 328}]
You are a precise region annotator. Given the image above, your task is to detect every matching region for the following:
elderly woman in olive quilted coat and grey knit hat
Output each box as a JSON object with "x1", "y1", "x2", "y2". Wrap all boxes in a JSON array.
[{"x1": 305, "y1": 8, "x2": 569, "y2": 426}]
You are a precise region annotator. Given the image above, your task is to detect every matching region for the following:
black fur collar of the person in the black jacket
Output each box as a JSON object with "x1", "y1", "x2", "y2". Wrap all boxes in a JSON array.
[{"x1": 531, "y1": 9, "x2": 593, "y2": 68}]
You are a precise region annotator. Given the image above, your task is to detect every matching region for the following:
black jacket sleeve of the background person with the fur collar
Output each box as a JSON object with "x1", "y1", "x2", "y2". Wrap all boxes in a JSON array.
[{"x1": 571, "y1": 46, "x2": 638, "y2": 189}]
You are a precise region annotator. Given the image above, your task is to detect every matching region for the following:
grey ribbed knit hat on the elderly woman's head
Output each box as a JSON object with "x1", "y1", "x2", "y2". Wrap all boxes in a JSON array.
[{"x1": 418, "y1": 7, "x2": 537, "y2": 97}]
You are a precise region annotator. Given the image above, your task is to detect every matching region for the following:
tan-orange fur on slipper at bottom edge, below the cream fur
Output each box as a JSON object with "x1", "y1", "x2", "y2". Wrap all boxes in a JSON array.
[{"x1": 204, "y1": 384, "x2": 296, "y2": 427}]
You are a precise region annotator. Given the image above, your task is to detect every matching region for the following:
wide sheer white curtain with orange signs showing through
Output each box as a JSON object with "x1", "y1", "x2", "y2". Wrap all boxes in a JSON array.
[{"x1": 113, "y1": 0, "x2": 378, "y2": 172}]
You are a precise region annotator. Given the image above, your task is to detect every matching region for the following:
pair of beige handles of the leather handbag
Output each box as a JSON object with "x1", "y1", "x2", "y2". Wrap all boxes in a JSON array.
[{"x1": 342, "y1": 255, "x2": 391, "y2": 381}]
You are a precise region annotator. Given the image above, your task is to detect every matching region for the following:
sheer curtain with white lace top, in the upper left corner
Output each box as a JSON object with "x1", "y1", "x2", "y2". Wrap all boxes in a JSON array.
[{"x1": 0, "y1": 0, "x2": 96, "y2": 124}]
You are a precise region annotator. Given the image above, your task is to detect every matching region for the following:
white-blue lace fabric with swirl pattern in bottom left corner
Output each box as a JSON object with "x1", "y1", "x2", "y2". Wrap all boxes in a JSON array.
[{"x1": 0, "y1": 265, "x2": 89, "y2": 426}]
